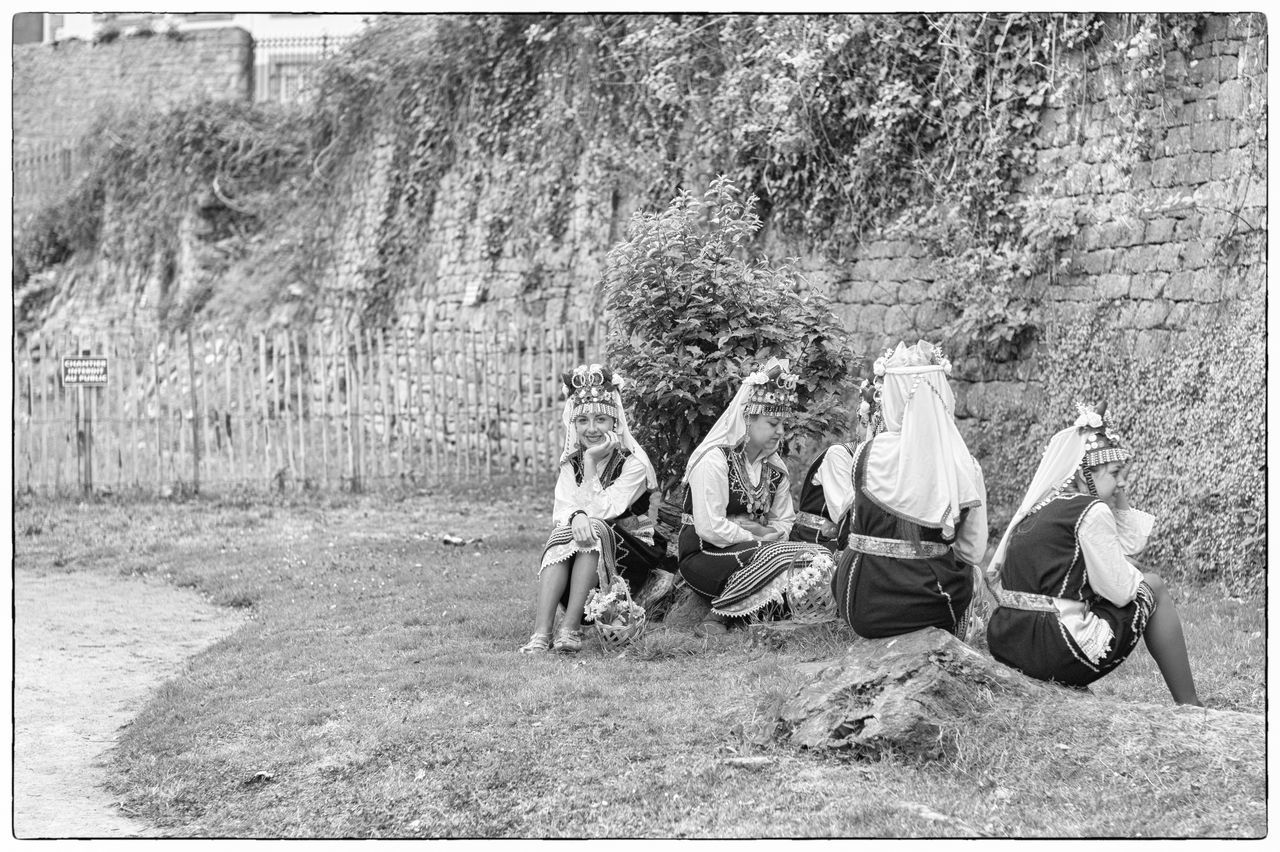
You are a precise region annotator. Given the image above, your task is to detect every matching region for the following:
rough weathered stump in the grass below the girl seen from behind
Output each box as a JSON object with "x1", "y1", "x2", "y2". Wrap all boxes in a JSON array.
[{"x1": 756, "y1": 627, "x2": 1065, "y2": 759}]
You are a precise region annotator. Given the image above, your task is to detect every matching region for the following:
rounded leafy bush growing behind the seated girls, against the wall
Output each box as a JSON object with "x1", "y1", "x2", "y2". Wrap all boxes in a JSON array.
[{"x1": 605, "y1": 178, "x2": 860, "y2": 487}]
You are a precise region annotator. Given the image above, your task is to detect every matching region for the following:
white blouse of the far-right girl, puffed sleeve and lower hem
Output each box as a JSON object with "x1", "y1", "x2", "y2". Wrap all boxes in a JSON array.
[{"x1": 1053, "y1": 501, "x2": 1156, "y2": 663}]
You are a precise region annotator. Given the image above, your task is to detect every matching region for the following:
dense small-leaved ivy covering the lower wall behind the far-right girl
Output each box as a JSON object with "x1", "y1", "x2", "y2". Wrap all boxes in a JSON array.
[{"x1": 979, "y1": 281, "x2": 1267, "y2": 592}]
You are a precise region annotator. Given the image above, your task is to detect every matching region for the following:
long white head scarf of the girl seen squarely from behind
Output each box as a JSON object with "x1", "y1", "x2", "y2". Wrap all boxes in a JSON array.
[{"x1": 865, "y1": 340, "x2": 987, "y2": 539}]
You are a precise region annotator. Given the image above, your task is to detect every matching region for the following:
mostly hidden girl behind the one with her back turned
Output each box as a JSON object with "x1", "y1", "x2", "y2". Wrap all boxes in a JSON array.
[{"x1": 791, "y1": 381, "x2": 873, "y2": 553}]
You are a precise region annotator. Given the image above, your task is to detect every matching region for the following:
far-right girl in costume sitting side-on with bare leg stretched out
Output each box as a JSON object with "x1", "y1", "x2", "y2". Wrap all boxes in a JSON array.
[{"x1": 987, "y1": 406, "x2": 1201, "y2": 705}]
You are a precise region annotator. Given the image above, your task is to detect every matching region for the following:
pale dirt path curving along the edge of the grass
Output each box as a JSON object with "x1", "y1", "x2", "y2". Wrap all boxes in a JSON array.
[{"x1": 13, "y1": 568, "x2": 243, "y2": 839}]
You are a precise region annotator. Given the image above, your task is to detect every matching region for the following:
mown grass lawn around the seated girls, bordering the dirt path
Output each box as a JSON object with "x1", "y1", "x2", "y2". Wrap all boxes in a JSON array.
[{"x1": 14, "y1": 489, "x2": 1267, "y2": 838}]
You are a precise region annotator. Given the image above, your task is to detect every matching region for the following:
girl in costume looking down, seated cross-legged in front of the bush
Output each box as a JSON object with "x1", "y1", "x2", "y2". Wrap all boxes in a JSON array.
[{"x1": 680, "y1": 358, "x2": 833, "y2": 635}]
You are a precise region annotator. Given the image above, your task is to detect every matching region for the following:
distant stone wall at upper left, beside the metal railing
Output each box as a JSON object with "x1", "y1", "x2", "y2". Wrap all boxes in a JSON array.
[{"x1": 13, "y1": 28, "x2": 253, "y2": 151}]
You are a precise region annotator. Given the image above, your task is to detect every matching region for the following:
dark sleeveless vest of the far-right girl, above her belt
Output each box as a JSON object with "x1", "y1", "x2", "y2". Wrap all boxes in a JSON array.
[{"x1": 1000, "y1": 494, "x2": 1098, "y2": 600}]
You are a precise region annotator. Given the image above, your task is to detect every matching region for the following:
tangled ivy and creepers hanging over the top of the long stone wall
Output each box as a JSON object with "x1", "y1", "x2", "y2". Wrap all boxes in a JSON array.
[{"x1": 23, "y1": 13, "x2": 1218, "y2": 337}]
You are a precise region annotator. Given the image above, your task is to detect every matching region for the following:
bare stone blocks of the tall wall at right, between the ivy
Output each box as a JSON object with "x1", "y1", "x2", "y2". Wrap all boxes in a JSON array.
[{"x1": 829, "y1": 14, "x2": 1267, "y2": 417}]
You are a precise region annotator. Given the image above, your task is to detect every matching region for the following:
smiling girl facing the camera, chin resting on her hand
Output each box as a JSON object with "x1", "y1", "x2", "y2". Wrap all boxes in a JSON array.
[{"x1": 520, "y1": 363, "x2": 662, "y2": 654}]
